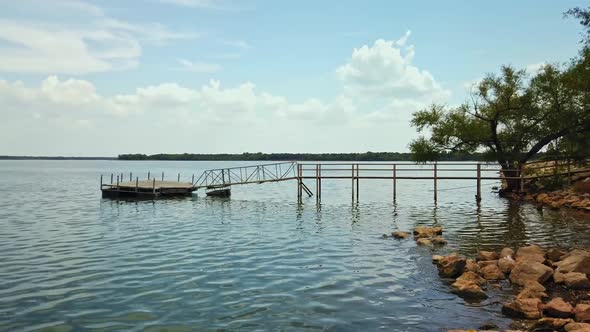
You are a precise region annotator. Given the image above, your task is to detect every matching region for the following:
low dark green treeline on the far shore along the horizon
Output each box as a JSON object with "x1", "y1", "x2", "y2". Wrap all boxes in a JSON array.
[{"x1": 119, "y1": 152, "x2": 484, "y2": 161}]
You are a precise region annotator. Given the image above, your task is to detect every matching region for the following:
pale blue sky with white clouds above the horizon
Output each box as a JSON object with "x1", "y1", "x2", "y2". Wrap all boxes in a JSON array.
[{"x1": 0, "y1": 0, "x2": 588, "y2": 156}]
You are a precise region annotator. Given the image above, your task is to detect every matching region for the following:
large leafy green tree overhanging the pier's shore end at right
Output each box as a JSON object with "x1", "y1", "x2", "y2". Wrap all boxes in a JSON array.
[{"x1": 410, "y1": 8, "x2": 590, "y2": 191}]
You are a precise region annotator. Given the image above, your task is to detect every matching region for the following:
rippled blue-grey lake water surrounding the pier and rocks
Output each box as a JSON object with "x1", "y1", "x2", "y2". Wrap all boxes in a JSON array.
[{"x1": 0, "y1": 161, "x2": 590, "y2": 331}]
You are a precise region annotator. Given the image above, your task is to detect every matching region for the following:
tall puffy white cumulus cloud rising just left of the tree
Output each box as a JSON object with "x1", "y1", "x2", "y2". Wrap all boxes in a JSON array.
[{"x1": 336, "y1": 32, "x2": 449, "y2": 99}]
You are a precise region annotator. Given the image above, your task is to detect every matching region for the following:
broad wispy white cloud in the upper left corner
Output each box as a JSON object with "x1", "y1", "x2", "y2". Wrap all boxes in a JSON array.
[{"x1": 0, "y1": 1, "x2": 196, "y2": 75}]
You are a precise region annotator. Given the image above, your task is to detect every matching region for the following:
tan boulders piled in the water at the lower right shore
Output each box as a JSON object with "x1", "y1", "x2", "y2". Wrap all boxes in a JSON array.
[{"x1": 384, "y1": 226, "x2": 590, "y2": 332}]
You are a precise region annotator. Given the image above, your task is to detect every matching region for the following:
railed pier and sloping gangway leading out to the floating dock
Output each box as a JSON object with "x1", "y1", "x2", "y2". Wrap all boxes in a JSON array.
[{"x1": 101, "y1": 161, "x2": 590, "y2": 204}]
